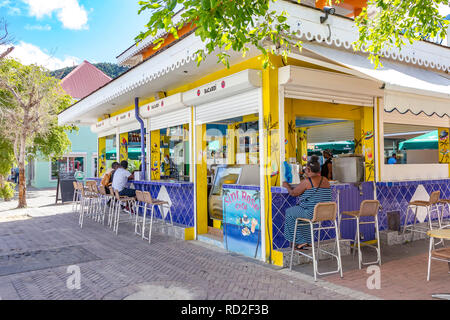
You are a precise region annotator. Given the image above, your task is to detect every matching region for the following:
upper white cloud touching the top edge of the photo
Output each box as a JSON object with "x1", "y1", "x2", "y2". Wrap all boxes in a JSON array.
[{"x1": 22, "y1": 0, "x2": 88, "y2": 30}]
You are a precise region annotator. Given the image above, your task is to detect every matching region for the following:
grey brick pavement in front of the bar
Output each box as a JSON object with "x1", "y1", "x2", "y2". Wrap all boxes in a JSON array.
[{"x1": 0, "y1": 191, "x2": 373, "y2": 300}]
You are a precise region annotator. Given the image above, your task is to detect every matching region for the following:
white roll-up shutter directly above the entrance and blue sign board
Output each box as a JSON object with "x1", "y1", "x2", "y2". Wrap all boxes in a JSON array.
[{"x1": 195, "y1": 89, "x2": 262, "y2": 124}]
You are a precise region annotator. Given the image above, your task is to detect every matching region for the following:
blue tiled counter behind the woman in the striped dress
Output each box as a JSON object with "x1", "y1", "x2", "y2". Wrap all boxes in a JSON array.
[{"x1": 272, "y1": 182, "x2": 375, "y2": 250}]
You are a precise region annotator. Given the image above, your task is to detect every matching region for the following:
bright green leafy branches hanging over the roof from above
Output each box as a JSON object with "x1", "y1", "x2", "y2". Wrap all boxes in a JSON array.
[{"x1": 136, "y1": 0, "x2": 450, "y2": 67}]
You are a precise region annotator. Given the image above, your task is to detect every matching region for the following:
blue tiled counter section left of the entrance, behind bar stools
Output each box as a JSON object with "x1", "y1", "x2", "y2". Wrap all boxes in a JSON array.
[{"x1": 131, "y1": 181, "x2": 194, "y2": 228}]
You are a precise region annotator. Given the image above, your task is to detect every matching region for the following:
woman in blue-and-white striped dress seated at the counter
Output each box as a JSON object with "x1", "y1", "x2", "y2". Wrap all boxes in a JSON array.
[{"x1": 283, "y1": 156, "x2": 333, "y2": 250}]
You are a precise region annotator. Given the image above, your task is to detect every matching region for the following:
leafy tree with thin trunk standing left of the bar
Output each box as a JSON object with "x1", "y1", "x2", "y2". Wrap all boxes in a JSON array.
[{"x1": 0, "y1": 59, "x2": 72, "y2": 208}]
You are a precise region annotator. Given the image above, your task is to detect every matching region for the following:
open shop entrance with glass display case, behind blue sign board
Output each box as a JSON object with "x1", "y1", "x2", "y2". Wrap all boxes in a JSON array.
[{"x1": 199, "y1": 114, "x2": 260, "y2": 242}]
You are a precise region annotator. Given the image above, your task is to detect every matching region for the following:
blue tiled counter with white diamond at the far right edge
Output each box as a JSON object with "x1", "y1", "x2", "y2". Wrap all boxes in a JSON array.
[{"x1": 377, "y1": 179, "x2": 450, "y2": 230}]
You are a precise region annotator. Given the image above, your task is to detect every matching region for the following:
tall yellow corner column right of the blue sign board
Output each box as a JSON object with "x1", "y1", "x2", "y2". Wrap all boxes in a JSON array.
[{"x1": 261, "y1": 56, "x2": 284, "y2": 263}]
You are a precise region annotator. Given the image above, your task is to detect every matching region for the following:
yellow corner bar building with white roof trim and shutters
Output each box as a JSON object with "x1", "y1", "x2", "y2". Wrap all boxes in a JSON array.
[{"x1": 59, "y1": 1, "x2": 450, "y2": 265}]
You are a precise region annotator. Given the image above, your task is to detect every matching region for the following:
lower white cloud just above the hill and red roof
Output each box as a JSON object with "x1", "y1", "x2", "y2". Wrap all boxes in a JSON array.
[{"x1": 0, "y1": 41, "x2": 80, "y2": 70}]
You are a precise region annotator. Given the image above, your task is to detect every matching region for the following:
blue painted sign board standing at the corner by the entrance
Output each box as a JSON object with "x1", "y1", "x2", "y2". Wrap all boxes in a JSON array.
[{"x1": 223, "y1": 187, "x2": 262, "y2": 259}]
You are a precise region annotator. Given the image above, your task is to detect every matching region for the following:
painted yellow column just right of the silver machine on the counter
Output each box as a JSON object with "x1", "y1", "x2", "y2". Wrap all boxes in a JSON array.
[{"x1": 361, "y1": 107, "x2": 375, "y2": 181}]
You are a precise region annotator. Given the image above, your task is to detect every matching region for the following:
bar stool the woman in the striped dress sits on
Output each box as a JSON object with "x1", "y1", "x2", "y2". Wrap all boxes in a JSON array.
[{"x1": 289, "y1": 202, "x2": 344, "y2": 281}]
